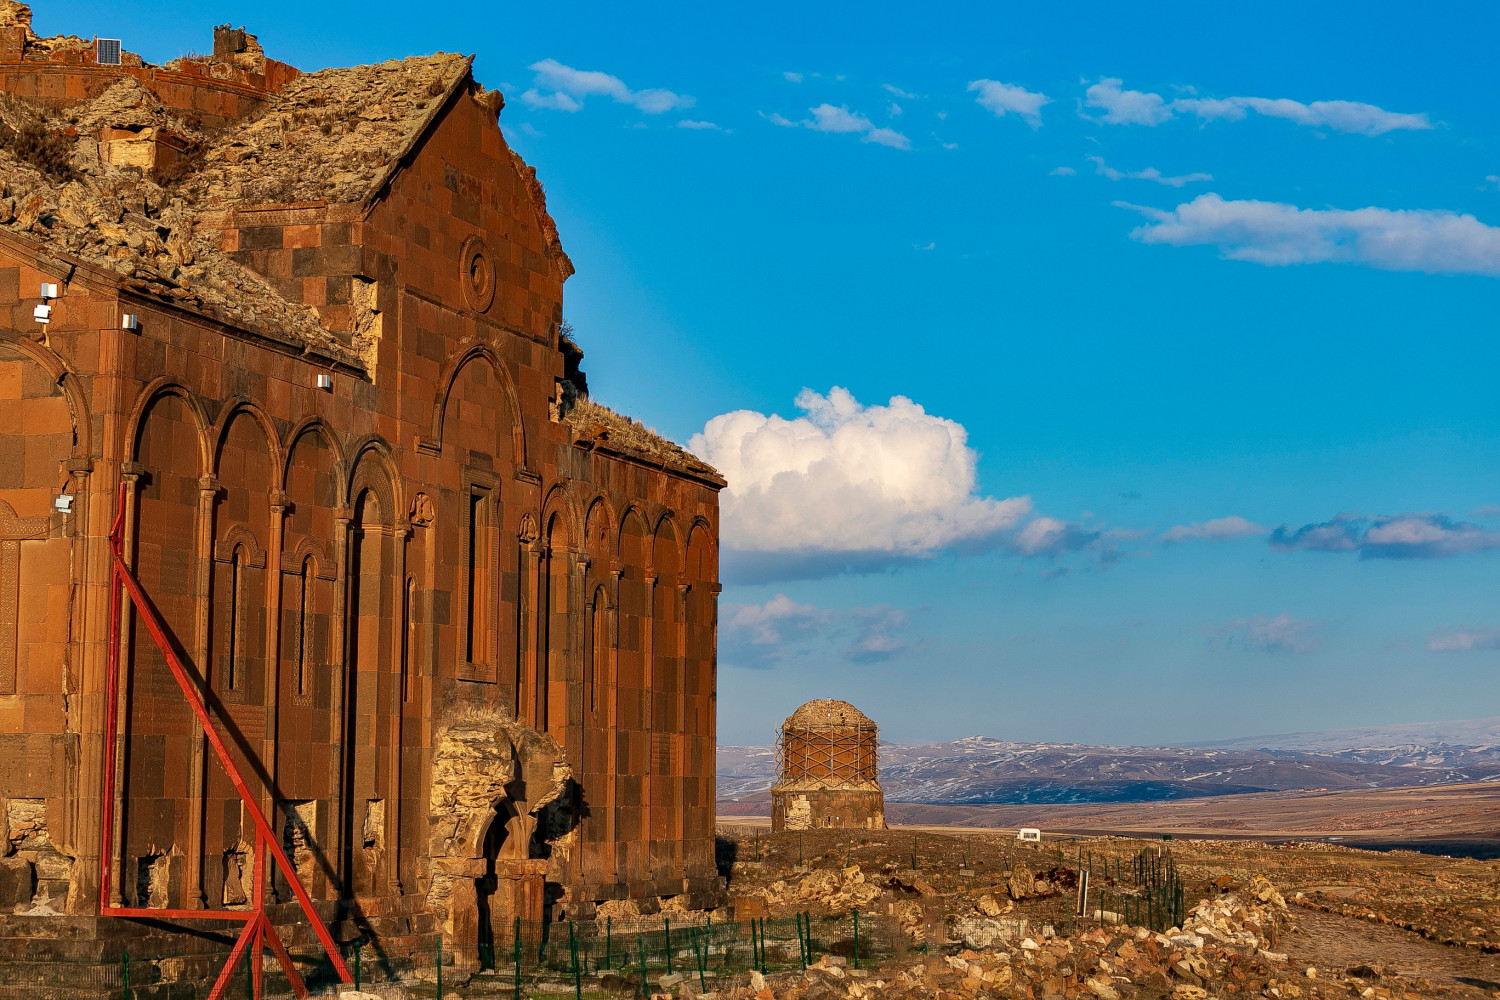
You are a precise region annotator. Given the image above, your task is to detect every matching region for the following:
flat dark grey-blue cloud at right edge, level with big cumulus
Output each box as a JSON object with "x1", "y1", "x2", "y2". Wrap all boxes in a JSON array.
[{"x1": 1271, "y1": 514, "x2": 1500, "y2": 559}]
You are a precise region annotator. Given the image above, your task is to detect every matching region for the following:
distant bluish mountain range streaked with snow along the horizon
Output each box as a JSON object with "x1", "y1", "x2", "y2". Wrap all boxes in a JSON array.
[{"x1": 719, "y1": 717, "x2": 1500, "y2": 811}]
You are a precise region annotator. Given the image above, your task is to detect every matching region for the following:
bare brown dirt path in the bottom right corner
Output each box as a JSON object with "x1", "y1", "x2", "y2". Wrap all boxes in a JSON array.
[{"x1": 1281, "y1": 910, "x2": 1500, "y2": 997}]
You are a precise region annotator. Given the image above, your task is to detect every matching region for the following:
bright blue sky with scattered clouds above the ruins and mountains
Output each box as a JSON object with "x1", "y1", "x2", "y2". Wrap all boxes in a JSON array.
[{"x1": 70, "y1": 1, "x2": 1500, "y2": 744}]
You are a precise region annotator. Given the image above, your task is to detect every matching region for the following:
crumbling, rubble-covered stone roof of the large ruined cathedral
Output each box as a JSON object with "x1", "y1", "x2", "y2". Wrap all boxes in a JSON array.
[{"x1": 0, "y1": 0, "x2": 722, "y2": 484}]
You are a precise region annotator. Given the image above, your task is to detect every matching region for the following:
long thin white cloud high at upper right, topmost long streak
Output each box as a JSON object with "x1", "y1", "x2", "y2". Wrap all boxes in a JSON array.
[{"x1": 1083, "y1": 76, "x2": 1433, "y2": 135}]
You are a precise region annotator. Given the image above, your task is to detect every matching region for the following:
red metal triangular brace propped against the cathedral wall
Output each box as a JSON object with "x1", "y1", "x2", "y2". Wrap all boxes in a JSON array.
[{"x1": 99, "y1": 483, "x2": 354, "y2": 1000}]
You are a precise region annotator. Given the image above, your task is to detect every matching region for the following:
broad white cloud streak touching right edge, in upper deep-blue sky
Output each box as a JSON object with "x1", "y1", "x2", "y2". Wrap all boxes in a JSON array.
[{"x1": 1116, "y1": 193, "x2": 1500, "y2": 276}]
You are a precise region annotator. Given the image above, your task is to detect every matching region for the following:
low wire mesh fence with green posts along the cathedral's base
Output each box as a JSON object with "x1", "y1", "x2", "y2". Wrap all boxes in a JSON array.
[{"x1": 0, "y1": 912, "x2": 921, "y2": 1000}]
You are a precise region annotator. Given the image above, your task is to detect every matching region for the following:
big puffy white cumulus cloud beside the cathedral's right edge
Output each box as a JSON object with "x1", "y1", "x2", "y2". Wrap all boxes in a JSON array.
[{"x1": 689, "y1": 387, "x2": 1100, "y2": 575}]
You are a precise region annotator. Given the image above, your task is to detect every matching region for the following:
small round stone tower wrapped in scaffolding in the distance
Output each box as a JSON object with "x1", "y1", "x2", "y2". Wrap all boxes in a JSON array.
[{"x1": 771, "y1": 699, "x2": 885, "y2": 831}]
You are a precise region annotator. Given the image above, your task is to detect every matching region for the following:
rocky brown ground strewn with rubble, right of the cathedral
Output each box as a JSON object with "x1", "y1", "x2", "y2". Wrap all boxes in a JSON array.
[{"x1": 672, "y1": 829, "x2": 1500, "y2": 1000}]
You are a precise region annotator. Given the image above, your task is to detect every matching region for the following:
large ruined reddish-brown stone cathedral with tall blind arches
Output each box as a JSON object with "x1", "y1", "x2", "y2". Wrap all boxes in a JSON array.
[{"x1": 0, "y1": 1, "x2": 725, "y2": 983}]
